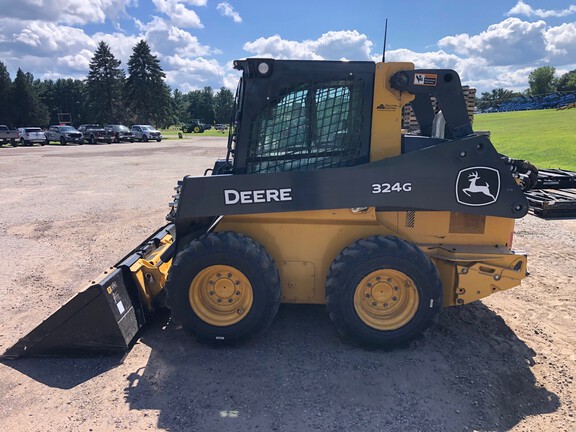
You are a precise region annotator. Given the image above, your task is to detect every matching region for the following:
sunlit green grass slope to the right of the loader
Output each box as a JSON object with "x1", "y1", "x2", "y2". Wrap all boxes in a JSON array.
[{"x1": 474, "y1": 109, "x2": 576, "y2": 171}]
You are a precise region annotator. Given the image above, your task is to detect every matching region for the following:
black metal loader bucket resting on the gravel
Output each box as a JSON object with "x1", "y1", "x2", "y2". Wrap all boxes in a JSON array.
[{"x1": 0, "y1": 227, "x2": 171, "y2": 359}]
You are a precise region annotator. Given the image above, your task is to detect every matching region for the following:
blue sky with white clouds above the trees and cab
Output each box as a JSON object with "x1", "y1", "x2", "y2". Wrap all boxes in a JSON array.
[{"x1": 0, "y1": 0, "x2": 576, "y2": 92}]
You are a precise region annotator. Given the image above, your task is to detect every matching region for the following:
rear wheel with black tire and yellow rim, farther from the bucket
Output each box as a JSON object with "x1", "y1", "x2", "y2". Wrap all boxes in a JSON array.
[{"x1": 326, "y1": 236, "x2": 443, "y2": 347}]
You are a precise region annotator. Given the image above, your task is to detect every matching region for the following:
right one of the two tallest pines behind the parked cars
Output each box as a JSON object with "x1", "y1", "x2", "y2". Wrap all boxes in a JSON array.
[{"x1": 125, "y1": 40, "x2": 173, "y2": 125}]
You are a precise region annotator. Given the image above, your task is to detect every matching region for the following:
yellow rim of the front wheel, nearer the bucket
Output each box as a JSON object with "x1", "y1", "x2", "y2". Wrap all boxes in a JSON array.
[{"x1": 188, "y1": 265, "x2": 254, "y2": 327}]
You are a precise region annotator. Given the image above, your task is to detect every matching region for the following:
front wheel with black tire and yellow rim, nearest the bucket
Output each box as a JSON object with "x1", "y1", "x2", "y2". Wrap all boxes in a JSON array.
[{"x1": 166, "y1": 232, "x2": 281, "y2": 342}]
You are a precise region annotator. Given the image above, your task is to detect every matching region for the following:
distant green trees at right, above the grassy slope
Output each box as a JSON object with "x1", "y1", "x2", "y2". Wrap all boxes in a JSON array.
[{"x1": 476, "y1": 66, "x2": 576, "y2": 110}]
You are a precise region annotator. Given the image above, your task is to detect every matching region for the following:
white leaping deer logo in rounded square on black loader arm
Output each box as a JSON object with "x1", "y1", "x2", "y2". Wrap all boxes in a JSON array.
[{"x1": 456, "y1": 167, "x2": 500, "y2": 206}]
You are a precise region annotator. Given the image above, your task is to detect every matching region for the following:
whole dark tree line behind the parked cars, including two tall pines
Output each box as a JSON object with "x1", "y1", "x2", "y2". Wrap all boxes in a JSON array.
[{"x1": 0, "y1": 40, "x2": 234, "y2": 128}]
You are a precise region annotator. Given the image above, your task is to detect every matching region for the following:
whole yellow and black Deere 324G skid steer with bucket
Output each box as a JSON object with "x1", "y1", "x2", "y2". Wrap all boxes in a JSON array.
[{"x1": 4, "y1": 59, "x2": 536, "y2": 357}]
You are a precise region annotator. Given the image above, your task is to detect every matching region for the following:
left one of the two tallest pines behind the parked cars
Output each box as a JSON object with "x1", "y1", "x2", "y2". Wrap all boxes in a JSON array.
[{"x1": 86, "y1": 41, "x2": 125, "y2": 123}]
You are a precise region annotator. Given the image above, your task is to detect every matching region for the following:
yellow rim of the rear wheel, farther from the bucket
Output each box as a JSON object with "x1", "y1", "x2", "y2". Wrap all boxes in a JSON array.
[{"x1": 354, "y1": 269, "x2": 419, "y2": 330}]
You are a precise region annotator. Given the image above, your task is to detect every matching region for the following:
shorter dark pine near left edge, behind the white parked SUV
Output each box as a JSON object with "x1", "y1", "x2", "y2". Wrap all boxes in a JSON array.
[{"x1": 10, "y1": 69, "x2": 48, "y2": 127}]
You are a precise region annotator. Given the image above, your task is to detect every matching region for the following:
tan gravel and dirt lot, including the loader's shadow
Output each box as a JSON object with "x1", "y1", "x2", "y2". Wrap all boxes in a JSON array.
[{"x1": 0, "y1": 137, "x2": 576, "y2": 431}]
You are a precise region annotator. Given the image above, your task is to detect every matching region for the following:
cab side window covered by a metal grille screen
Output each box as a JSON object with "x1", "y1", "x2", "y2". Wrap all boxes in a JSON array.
[{"x1": 247, "y1": 80, "x2": 363, "y2": 173}]
